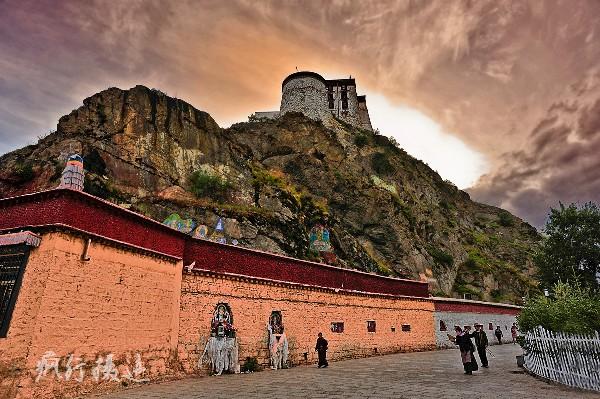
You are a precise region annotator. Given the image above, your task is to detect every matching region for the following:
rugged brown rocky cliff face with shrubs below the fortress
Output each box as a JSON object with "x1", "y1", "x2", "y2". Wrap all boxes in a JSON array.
[{"x1": 0, "y1": 86, "x2": 539, "y2": 301}]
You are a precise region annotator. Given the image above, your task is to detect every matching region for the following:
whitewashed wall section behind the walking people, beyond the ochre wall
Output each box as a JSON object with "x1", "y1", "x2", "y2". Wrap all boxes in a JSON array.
[{"x1": 434, "y1": 312, "x2": 517, "y2": 348}]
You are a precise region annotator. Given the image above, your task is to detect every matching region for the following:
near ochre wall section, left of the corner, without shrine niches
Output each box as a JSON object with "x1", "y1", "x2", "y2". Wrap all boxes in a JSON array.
[{"x1": 0, "y1": 233, "x2": 182, "y2": 398}]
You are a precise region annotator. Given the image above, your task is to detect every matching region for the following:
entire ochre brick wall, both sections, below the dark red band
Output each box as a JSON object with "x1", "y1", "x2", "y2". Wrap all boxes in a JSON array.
[{"x1": 0, "y1": 232, "x2": 435, "y2": 398}]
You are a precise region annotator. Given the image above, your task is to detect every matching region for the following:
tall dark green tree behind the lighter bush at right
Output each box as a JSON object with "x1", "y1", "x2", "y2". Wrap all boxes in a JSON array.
[{"x1": 535, "y1": 202, "x2": 600, "y2": 291}]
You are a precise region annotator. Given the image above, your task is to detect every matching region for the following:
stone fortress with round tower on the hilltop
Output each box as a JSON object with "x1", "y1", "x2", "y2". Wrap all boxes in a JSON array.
[{"x1": 250, "y1": 71, "x2": 373, "y2": 131}]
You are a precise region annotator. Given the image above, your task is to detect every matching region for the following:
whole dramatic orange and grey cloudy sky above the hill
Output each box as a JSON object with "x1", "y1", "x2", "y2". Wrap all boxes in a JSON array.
[{"x1": 0, "y1": 0, "x2": 600, "y2": 226}]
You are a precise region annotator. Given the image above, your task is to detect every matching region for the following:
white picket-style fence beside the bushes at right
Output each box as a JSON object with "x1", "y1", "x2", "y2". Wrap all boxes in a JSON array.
[{"x1": 524, "y1": 327, "x2": 600, "y2": 391}]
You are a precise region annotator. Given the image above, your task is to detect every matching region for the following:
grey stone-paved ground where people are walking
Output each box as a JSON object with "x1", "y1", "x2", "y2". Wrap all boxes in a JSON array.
[{"x1": 101, "y1": 344, "x2": 600, "y2": 399}]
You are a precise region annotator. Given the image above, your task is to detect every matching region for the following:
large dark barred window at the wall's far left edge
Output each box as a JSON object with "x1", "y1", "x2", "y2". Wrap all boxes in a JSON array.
[{"x1": 0, "y1": 245, "x2": 29, "y2": 338}]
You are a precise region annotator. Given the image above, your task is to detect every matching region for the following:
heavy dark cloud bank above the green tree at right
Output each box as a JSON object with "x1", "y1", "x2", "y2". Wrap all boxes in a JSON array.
[{"x1": 470, "y1": 69, "x2": 600, "y2": 226}]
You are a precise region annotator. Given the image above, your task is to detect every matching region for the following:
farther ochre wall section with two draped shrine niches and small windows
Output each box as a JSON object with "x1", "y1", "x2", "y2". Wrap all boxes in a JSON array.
[{"x1": 178, "y1": 272, "x2": 435, "y2": 372}]
